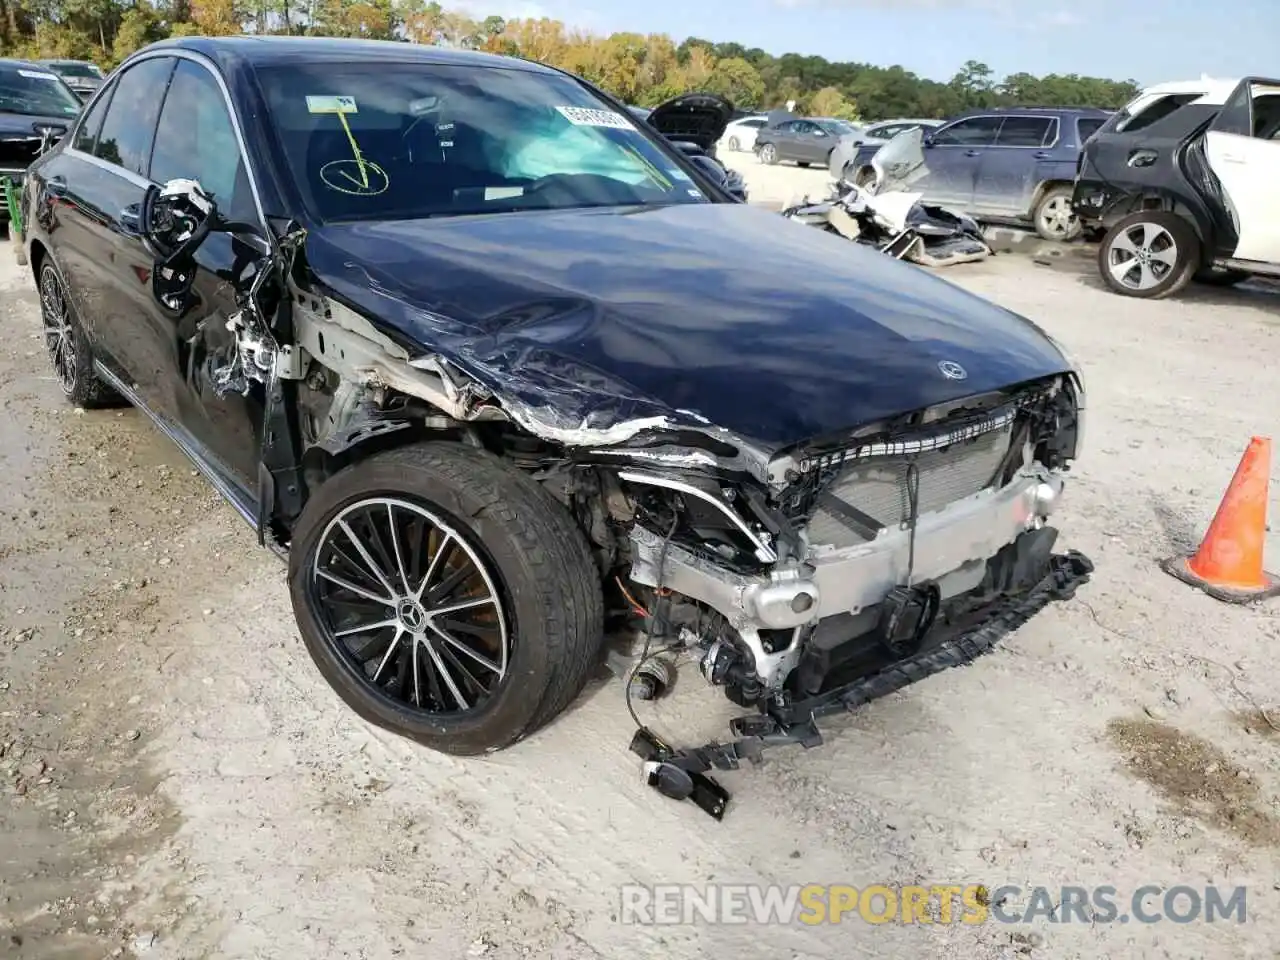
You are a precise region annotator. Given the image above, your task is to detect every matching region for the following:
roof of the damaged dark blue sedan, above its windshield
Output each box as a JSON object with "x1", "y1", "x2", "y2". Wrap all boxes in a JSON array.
[{"x1": 136, "y1": 36, "x2": 557, "y2": 73}]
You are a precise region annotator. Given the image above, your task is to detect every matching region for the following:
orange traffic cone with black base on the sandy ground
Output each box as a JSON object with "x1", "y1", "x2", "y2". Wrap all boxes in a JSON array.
[{"x1": 1161, "y1": 436, "x2": 1280, "y2": 603}]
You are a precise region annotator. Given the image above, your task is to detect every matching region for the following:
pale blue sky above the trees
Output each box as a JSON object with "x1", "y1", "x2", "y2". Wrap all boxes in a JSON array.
[{"x1": 471, "y1": 0, "x2": 1280, "y2": 84}]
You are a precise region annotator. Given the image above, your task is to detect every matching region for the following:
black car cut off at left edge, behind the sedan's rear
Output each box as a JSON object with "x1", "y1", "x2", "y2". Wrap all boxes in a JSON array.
[{"x1": 0, "y1": 59, "x2": 81, "y2": 223}]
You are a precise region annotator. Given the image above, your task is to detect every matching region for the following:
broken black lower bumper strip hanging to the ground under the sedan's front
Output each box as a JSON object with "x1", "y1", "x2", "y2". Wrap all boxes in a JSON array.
[{"x1": 631, "y1": 550, "x2": 1093, "y2": 819}]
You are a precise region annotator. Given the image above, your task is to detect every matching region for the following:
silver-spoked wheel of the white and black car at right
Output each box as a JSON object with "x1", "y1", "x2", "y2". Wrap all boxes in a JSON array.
[{"x1": 1098, "y1": 210, "x2": 1199, "y2": 300}]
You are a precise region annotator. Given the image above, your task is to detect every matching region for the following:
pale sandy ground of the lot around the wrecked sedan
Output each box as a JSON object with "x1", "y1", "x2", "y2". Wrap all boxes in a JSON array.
[{"x1": 0, "y1": 220, "x2": 1280, "y2": 960}]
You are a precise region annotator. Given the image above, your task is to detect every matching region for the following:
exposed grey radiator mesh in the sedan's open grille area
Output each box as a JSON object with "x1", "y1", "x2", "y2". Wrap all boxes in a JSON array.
[{"x1": 809, "y1": 424, "x2": 1012, "y2": 547}]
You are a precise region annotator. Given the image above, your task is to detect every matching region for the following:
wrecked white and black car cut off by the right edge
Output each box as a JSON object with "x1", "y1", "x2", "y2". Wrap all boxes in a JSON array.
[{"x1": 1073, "y1": 77, "x2": 1280, "y2": 300}]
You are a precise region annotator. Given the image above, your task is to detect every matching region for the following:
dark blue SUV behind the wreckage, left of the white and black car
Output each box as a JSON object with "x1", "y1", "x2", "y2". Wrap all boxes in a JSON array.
[{"x1": 845, "y1": 106, "x2": 1110, "y2": 241}]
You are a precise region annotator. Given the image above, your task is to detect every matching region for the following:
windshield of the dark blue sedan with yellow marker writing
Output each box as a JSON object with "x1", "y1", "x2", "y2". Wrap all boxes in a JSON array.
[{"x1": 249, "y1": 63, "x2": 709, "y2": 221}]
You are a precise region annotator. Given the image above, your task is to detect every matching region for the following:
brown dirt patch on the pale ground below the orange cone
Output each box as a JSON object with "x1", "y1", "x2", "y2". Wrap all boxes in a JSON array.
[{"x1": 1107, "y1": 717, "x2": 1280, "y2": 846}]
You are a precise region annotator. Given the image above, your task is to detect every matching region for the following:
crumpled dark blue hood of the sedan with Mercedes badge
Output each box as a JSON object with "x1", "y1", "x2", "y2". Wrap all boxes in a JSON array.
[{"x1": 306, "y1": 204, "x2": 1069, "y2": 453}]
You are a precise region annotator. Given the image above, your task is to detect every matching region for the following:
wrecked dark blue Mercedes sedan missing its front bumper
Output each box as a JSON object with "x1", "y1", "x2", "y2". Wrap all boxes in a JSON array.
[{"x1": 23, "y1": 37, "x2": 1091, "y2": 815}]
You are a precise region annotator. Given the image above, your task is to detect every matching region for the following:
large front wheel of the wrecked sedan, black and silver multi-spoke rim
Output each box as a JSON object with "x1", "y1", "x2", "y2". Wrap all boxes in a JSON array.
[{"x1": 289, "y1": 443, "x2": 603, "y2": 755}]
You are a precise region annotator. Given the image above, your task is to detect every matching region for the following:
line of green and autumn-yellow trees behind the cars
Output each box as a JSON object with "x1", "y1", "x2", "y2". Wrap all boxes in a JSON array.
[{"x1": 0, "y1": 0, "x2": 1137, "y2": 119}]
